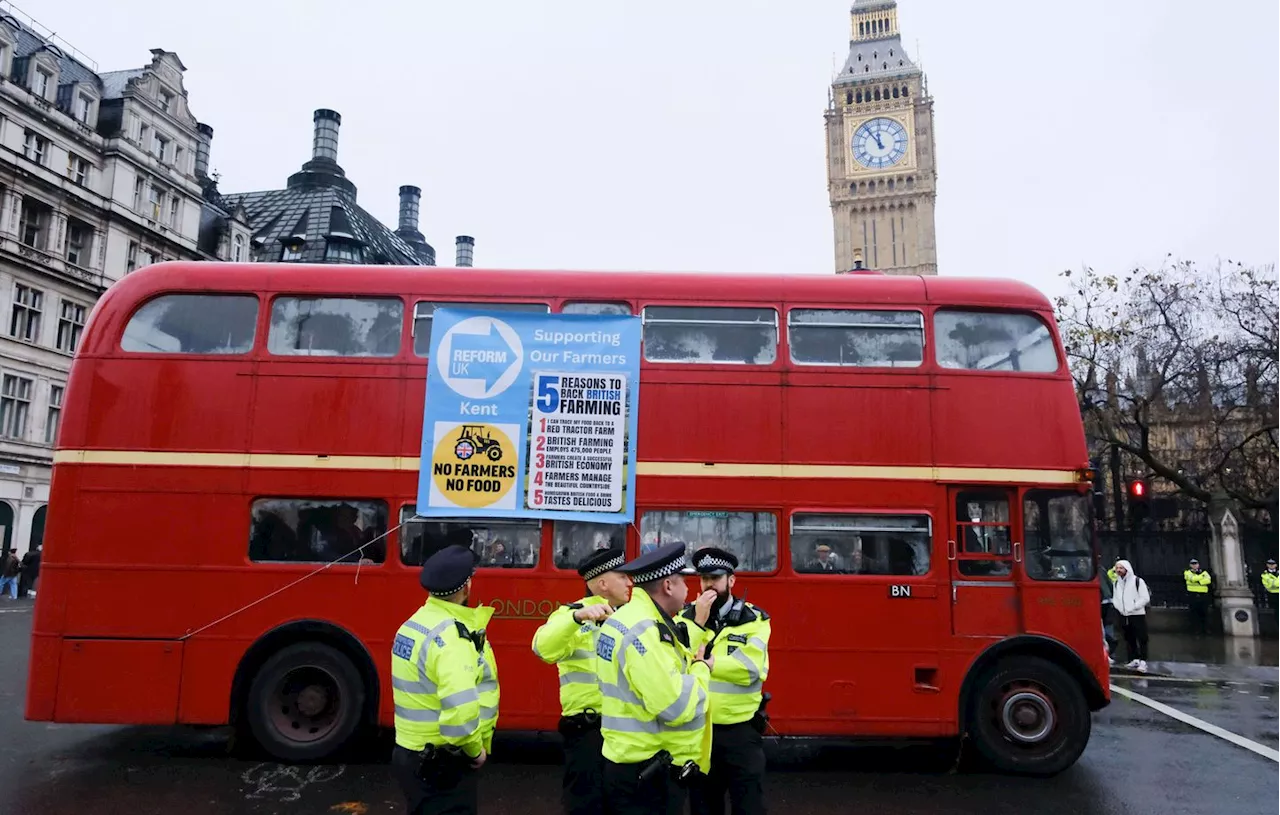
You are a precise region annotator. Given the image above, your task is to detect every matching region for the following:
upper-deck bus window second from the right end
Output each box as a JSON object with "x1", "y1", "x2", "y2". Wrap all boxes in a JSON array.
[{"x1": 787, "y1": 308, "x2": 924, "y2": 367}]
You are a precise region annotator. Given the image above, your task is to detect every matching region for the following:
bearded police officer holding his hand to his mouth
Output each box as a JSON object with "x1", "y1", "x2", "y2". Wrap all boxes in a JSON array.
[{"x1": 684, "y1": 546, "x2": 771, "y2": 815}]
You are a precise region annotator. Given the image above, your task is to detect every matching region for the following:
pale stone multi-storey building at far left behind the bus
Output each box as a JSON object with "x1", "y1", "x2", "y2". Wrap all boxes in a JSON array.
[{"x1": 0, "y1": 3, "x2": 248, "y2": 560}]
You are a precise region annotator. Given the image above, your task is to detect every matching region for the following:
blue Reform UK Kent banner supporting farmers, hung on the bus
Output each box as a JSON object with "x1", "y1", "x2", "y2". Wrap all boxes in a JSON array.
[{"x1": 417, "y1": 308, "x2": 641, "y2": 523}]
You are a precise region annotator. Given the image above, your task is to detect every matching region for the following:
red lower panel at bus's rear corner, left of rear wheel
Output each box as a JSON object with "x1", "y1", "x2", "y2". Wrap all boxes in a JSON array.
[{"x1": 56, "y1": 640, "x2": 182, "y2": 724}]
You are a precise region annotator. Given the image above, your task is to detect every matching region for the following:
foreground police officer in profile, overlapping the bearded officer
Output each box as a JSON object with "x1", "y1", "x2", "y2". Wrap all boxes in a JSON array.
[{"x1": 595, "y1": 542, "x2": 714, "y2": 815}]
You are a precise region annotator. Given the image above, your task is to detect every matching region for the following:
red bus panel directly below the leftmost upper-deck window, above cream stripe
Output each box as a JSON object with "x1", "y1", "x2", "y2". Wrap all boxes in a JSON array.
[{"x1": 74, "y1": 356, "x2": 253, "y2": 450}]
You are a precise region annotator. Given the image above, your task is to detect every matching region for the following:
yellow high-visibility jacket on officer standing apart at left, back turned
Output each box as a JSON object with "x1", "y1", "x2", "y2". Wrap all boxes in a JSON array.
[{"x1": 392, "y1": 597, "x2": 498, "y2": 757}]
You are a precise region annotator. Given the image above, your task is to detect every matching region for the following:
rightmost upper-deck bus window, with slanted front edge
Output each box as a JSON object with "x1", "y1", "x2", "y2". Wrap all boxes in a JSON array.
[{"x1": 933, "y1": 311, "x2": 1059, "y2": 374}]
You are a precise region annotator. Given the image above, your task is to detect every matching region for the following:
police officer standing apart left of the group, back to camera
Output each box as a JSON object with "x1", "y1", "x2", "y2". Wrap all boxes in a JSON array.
[{"x1": 392, "y1": 546, "x2": 498, "y2": 815}]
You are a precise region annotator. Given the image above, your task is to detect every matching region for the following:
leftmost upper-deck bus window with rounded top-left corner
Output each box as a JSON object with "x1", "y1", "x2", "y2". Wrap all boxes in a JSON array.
[{"x1": 120, "y1": 294, "x2": 257, "y2": 354}]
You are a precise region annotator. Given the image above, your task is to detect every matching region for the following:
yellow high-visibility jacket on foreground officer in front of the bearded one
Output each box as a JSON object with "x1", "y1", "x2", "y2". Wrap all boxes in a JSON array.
[{"x1": 595, "y1": 589, "x2": 712, "y2": 773}]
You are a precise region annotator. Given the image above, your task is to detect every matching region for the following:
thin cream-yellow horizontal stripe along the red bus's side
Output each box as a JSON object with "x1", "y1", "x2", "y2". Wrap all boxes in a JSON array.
[{"x1": 54, "y1": 450, "x2": 1079, "y2": 484}]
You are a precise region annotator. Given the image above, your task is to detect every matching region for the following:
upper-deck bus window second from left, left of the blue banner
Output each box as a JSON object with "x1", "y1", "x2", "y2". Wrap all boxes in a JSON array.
[{"x1": 266, "y1": 297, "x2": 404, "y2": 357}]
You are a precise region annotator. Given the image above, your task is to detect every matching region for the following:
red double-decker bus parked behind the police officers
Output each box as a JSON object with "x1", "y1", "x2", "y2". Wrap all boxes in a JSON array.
[{"x1": 27, "y1": 262, "x2": 1110, "y2": 773}]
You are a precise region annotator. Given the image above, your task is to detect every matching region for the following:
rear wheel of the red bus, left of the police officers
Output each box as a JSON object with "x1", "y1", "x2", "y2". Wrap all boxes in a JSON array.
[{"x1": 246, "y1": 642, "x2": 365, "y2": 761}]
